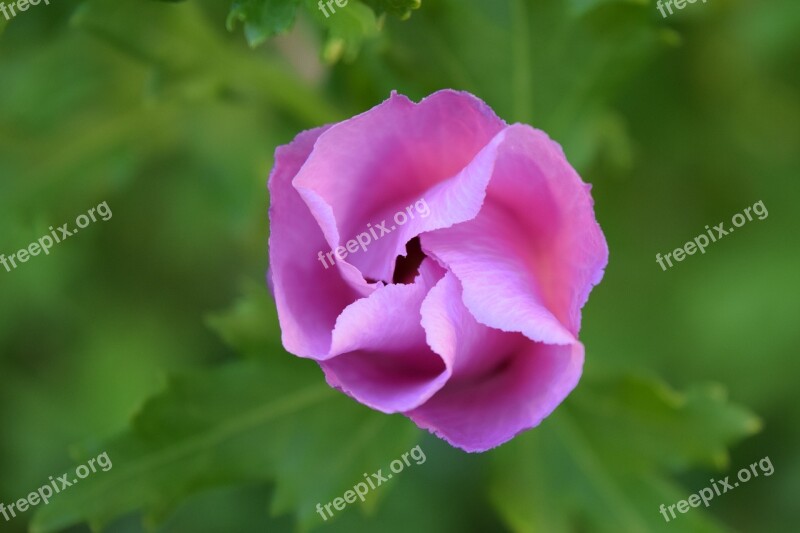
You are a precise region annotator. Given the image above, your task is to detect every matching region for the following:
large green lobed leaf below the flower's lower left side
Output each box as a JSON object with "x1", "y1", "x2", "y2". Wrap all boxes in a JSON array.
[{"x1": 32, "y1": 353, "x2": 419, "y2": 533}]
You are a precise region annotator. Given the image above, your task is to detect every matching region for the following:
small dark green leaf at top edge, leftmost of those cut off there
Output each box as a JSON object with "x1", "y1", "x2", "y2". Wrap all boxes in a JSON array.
[{"x1": 226, "y1": 0, "x2": 300, "y2": 47}]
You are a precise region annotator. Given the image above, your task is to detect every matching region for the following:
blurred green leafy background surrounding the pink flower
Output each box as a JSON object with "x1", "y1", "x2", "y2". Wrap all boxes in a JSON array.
[{"x1": 0, "y1": 0, "x2": 800, "y2": 533}]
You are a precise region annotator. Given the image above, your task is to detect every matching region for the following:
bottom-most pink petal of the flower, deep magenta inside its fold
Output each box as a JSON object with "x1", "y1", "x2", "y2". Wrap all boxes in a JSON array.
[{"x1": 405, "y1": 273, "x2": 583, "y2": 452}]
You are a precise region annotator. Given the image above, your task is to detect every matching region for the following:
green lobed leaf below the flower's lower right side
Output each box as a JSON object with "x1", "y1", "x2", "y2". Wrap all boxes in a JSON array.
[{"x1": 490, "y1": 378, "x2": 760, "y2": 533}]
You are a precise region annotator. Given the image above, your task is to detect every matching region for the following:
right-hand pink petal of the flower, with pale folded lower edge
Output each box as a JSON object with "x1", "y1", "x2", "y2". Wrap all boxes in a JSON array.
[{"x1": 421, "y1": 125, "x2": 608, "y2": 344}]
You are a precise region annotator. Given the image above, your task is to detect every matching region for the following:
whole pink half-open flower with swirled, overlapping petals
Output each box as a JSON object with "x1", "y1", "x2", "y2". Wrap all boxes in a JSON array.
[{"x1": 269, "y1": 90, "x2": 608, "y2": 452}]
